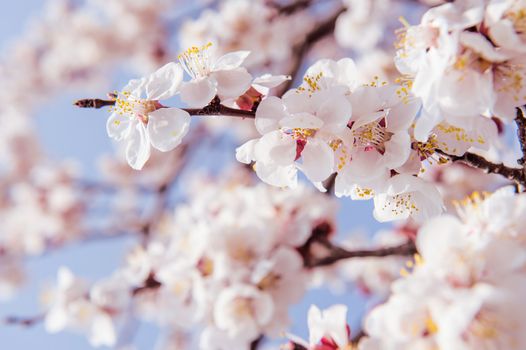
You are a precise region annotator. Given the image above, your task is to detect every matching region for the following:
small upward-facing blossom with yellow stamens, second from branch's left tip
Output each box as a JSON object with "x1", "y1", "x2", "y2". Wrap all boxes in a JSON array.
[{"x1": 179, "y1": 43, "x2": 252, "y2": 108}]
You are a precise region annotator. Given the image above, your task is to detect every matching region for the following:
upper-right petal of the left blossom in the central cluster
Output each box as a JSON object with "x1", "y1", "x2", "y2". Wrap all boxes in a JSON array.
[{"x1": 316, "y1": 96, "x2": 352, "y2": 133}]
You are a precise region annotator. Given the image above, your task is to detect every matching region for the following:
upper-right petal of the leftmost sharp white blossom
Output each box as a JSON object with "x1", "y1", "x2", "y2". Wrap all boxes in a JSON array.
[{"x1": 146, "y1": 62, "x2": 183, "y2": 100}]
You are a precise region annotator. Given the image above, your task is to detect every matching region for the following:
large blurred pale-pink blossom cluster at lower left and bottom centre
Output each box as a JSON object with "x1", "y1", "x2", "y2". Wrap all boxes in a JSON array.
[{"x1": 41, "y1": 180, "x2": 336, "y2": 349}]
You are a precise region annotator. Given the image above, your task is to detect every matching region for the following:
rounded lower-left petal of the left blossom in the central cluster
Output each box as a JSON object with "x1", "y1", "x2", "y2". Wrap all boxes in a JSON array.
[{"x1": 254, "y1": 130, "x2": 296, "y2": 166}]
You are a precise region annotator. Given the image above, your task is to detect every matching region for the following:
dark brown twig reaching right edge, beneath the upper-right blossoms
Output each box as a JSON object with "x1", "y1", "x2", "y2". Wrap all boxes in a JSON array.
[{"x1": 435, "y1": 149, "x2": 526, "y2": 187}]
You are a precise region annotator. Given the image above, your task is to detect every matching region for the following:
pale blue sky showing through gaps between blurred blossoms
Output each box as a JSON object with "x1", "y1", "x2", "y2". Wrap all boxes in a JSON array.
[{"x1": 0, "y1": 0, "x2": 388, "y2": 350}]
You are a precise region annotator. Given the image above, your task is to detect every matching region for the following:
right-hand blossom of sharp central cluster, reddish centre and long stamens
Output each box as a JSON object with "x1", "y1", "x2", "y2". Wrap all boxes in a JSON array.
[{"x1": 334, "y1": 85, "x2": 420, "y2": 198}]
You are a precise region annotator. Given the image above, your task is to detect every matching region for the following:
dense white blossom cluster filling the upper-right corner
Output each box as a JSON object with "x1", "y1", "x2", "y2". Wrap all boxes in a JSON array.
[{"x1": 395, "y1": 0, "x2": 526, "y2": 142}]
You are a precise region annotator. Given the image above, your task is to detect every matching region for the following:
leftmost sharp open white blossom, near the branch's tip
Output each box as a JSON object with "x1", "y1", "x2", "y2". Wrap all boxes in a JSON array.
[{"x1": 106, "y1": 62, "x2": 190, "y2": 169}]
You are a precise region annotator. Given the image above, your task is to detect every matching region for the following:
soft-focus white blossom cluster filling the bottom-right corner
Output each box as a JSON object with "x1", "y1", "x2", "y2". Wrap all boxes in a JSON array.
[{"x1": 360, "y1": 187, "x2": 526, "y2": 350}]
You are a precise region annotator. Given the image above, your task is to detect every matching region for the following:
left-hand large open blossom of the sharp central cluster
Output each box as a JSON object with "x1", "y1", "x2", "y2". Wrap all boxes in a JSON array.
[{"x1": 236, "y1": 82, "x2": 352, "y2": 187}]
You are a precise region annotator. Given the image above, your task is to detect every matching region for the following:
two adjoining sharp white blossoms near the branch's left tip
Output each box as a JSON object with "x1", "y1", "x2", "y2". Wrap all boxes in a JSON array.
[{"x1": 107, "y1": 43, "x2": 289, "y2": 169}]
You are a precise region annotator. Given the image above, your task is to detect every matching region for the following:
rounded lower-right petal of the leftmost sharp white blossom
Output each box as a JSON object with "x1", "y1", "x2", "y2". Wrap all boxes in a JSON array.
[{"x1": 147, "y1": 108, "x2": 190, "y2": 152}]
